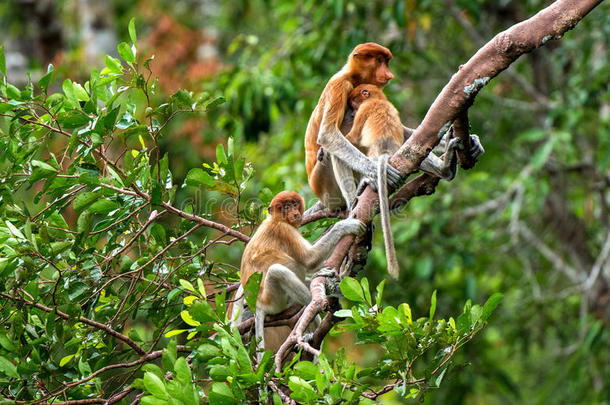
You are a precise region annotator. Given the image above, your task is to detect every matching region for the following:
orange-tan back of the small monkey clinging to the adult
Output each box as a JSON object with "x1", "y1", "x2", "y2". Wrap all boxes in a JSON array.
[{"x1": 356, "y1": 99, "x2": 404, "y2": 157}]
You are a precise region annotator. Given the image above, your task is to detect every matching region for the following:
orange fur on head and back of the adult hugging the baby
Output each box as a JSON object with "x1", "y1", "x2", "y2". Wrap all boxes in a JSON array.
[{"x1": 305, "y1": 42, "x2": 394, "y2": 208}]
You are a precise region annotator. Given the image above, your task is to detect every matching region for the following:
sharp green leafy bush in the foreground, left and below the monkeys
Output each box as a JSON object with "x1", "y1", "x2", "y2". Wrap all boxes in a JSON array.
[{"x1": 0, "y1": 21, "x2": 498, "y2": 404}]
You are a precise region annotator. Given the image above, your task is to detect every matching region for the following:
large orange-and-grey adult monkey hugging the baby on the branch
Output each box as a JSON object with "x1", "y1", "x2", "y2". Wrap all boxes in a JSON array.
[{"x1": 305, "y1": 42, "x2": 483, "y2": 212}]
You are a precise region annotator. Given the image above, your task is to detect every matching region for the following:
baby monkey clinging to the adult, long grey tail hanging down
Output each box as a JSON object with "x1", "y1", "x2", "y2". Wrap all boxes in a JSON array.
[{"x1": 346, "y1": 84, "x2": 460, "y2": 278}]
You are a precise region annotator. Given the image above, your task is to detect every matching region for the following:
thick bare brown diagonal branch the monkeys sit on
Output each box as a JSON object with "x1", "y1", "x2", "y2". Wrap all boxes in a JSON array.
[{"x1": 276, "y1": 0, "x2": 602, "y2": 371}]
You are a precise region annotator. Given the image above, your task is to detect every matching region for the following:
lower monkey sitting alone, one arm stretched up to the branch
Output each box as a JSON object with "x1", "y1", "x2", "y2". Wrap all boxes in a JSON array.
[{"x1": 236, "y1": 191, "x2": 366, "y2": 360}]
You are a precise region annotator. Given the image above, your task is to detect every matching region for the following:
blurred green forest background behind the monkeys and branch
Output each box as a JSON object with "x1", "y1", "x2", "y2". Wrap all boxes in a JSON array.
[{"x1": 0, "y1": 0, "x2": 610, "y2": 404}]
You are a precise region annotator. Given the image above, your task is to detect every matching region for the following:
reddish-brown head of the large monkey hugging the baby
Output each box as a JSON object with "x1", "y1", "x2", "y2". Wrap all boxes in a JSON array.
[{"x1": 347, "y1": 42, "x2": 394, "y2": 87}]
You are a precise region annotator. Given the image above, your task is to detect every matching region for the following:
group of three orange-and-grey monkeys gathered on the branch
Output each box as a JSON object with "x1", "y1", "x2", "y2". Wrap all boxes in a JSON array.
[{"x1": 233, "y1": 42, "x2": 483, "y2": 359}]
